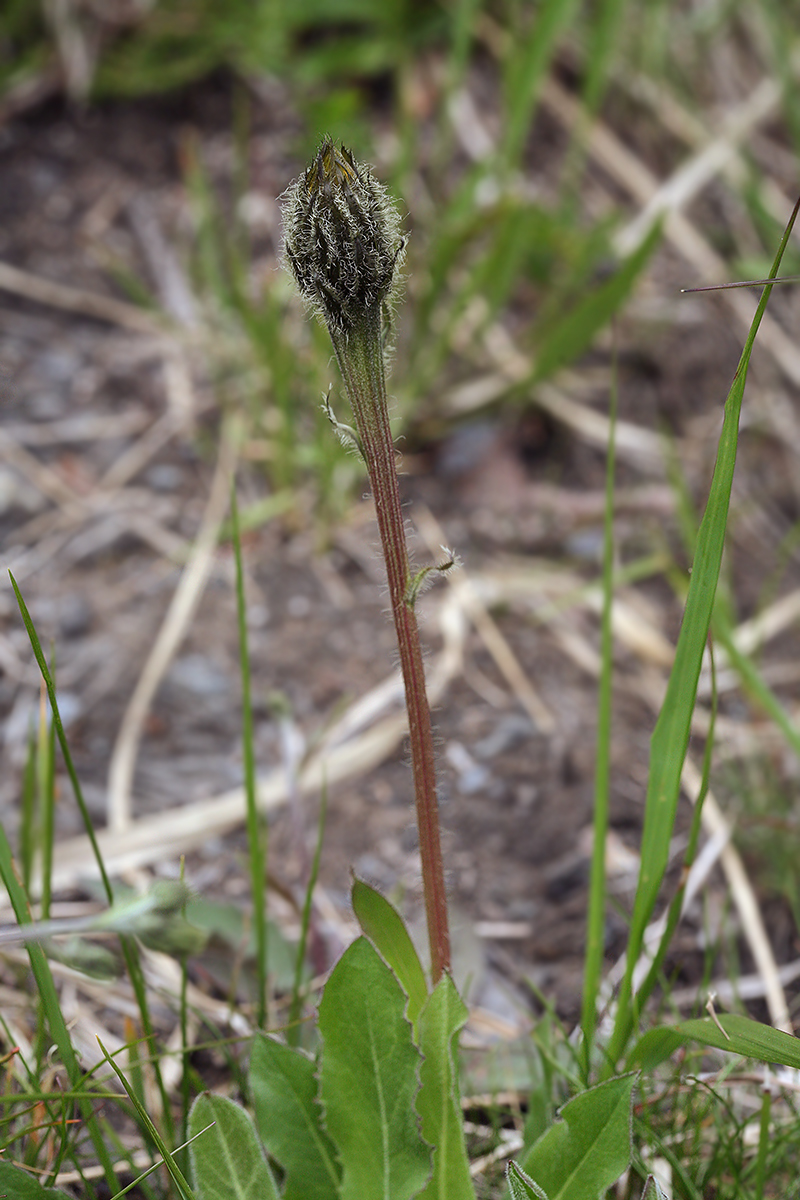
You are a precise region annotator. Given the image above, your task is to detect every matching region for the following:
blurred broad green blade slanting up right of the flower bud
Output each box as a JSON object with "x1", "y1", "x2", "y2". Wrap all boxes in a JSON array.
[{"x1": 533, "y1": 224, "x2": 661, "y2": 383}]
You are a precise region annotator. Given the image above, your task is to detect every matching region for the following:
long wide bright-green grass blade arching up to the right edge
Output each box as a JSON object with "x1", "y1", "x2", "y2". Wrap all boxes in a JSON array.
[{"x1": 608, "y1": 192, "x2": 800, "y2": 1070}]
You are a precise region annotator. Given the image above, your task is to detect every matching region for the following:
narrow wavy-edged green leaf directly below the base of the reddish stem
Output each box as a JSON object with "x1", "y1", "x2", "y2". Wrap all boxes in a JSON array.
[{"x1": 416, "y1": 976, "x2": 475, "y2": 1200}]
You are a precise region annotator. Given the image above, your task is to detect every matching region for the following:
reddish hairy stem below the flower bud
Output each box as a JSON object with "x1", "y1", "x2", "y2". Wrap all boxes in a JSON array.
[{"x1": 331, "y1": 312, "x2": 450, "y2": 983}]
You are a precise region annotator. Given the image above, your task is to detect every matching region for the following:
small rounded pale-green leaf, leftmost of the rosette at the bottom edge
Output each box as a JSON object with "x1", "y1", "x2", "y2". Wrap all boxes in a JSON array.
[{"x1": 188, "y1": 1092, "x2": 278, "y2": 1200}]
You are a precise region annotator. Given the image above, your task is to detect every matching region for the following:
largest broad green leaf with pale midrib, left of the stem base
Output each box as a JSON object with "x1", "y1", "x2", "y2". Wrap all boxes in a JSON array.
[{"x1": 319, "y1": 937, "x2": 431, "y2": 1200}]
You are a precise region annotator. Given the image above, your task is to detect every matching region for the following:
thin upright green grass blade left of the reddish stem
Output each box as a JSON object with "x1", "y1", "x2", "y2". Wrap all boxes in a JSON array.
[{"x1": 230, "y1": 482, "x2": 267, "y2": 1030}]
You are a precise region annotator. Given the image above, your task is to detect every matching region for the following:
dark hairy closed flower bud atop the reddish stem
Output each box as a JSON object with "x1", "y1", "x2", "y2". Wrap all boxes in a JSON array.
[{"x1": 283, "y1": 138, "x2": 405, "y2": 334}]
